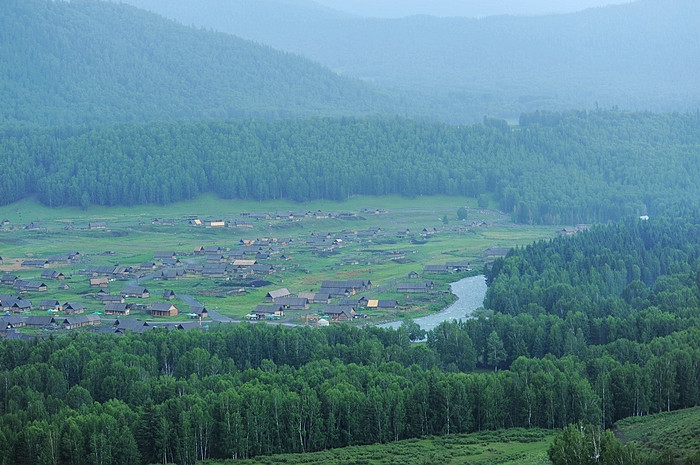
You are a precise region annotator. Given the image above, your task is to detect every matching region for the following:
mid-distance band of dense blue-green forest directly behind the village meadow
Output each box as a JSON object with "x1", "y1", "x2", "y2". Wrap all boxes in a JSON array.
[{"x1": 0, "y1": 111, "x2": 700, "y2": 224}]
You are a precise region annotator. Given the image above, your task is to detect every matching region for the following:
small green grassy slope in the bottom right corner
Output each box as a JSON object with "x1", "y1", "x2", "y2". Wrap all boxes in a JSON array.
[{"x1": 615, "y1": 407, "x2": 700, "y2": 459}]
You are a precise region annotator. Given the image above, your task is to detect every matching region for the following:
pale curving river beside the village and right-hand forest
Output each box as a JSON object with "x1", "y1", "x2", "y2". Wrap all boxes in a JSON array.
[{"x1": 377, "y1": 275, "x2": 486, "y2": 331}]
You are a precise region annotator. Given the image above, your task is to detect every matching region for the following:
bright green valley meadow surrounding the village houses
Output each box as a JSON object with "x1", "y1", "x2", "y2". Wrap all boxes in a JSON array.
[{"x1": 0, "y1": 195, "x2": 558, "y2": 321}]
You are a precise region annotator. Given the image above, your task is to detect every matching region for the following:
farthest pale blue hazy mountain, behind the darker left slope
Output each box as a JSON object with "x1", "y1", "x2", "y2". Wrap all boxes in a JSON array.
[{"x1": 127, "y1": 0, "x2": 700, "y2": 122}]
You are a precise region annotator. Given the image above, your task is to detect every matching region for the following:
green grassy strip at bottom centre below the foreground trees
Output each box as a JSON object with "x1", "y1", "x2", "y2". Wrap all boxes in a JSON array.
[{"x1": 203, "y1": 428, "x2": 554, "y2": 465}]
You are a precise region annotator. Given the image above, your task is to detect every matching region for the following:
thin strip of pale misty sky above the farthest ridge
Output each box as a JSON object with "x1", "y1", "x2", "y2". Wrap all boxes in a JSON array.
[{"x1": 314, "y1": 0, "x2": 632, "y2": 18}]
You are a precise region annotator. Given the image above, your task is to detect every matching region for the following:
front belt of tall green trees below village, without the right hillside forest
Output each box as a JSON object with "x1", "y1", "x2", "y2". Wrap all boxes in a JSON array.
[{"x1": 0, "y1": 323, "x2": 700, "y2": 464}]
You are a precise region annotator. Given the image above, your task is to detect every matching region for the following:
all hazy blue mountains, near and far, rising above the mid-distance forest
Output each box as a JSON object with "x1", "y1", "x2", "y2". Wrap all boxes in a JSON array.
[{"x1": 0, "y1": 0, "x2": 700, "y2": 125}]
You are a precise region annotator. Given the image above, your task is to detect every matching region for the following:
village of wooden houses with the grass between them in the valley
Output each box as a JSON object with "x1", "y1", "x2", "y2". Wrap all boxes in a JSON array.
[{"x1": 0, "y1": 205, "x2": 508, "y2": 338}]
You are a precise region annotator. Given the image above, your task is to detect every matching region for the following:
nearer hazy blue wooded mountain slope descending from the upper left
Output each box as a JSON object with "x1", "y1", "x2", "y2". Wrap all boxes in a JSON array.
[{"x1": 0, "y1": 0, "x2": 404, "y2": 125}]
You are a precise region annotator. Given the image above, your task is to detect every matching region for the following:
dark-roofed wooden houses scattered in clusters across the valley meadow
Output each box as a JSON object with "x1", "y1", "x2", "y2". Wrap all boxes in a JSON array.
[{"x1": 0, "y1": 209, "x2": 482, "y2": 338}]
